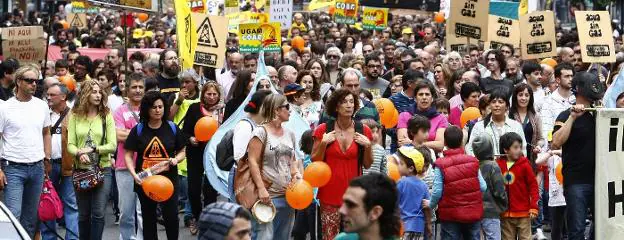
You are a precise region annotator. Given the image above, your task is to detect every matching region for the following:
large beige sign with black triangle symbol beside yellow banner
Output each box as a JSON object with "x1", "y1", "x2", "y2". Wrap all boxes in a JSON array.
[{"x1": 193, "y1": 13, "x2": 228, "y2": 68}]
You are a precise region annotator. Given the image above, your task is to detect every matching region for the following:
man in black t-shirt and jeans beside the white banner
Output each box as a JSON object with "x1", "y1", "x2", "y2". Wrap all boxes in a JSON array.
[{"x1": 552, "y1": 72, "x2": 604, "y2": 240}]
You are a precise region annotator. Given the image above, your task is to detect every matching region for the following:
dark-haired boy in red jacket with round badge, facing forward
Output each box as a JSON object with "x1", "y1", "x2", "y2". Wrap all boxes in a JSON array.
[{"x1": 496, "y1": 132, "x2": 539, "y2": 240}]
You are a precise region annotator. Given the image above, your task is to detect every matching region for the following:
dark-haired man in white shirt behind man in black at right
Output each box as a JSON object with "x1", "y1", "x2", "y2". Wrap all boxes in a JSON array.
[{"x1": 540, "y1": 62, "x2": 576, "y2": 139}]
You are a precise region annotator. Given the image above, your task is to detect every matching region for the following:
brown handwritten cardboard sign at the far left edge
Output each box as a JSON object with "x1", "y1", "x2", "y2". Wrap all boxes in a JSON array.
[{"x1": 2, "y1": 26, "x2": 47, "y2": 63}]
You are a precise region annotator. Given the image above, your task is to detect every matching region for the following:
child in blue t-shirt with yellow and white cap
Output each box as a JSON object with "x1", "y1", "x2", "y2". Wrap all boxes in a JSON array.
[{"x1": 397, "y1": 147, "x2": 432, "y2": 240}]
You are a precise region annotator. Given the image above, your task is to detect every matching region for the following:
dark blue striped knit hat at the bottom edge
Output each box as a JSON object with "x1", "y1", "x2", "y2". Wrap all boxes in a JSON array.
[{"x1": 198, "y1": 202, "x2": 241, "y2": 240}]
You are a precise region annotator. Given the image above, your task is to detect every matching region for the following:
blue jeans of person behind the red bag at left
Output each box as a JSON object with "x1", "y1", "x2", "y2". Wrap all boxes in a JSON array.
[{"x1": 41, "y1": 163, "x2": 78, "y2": 240}]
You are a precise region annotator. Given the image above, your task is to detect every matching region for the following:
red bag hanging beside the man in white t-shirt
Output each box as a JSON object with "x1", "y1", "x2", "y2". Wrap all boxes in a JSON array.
[{"x1": 37, "y1": 178, "x2": 63, "y2": 221}]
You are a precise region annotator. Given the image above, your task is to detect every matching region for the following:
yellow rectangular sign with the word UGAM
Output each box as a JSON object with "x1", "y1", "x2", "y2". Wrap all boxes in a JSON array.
[{"x1": 238, "y1": 22, "x2": 282, "y2": 53}]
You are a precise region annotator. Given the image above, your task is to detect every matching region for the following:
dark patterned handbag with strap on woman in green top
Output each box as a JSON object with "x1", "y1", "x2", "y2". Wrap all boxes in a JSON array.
[{"x1": 72, "y1": 117, "x2": 106, "y2": 192}]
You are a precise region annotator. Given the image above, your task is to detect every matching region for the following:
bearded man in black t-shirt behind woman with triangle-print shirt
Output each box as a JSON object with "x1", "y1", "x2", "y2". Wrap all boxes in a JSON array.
[{"x1": 156, "y1": 49, "x2": 181, "y2": 106}]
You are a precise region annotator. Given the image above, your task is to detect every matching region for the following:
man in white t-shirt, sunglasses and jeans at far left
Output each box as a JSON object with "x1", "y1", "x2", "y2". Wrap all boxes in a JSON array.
[{"x1": 0, "y1": 65, "x2": 51, "y2": 238}]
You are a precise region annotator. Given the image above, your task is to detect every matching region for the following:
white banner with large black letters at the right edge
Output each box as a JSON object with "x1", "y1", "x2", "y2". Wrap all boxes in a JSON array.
[{"x1": 596, "y1": 109, "x2": 624, "y2": 240}]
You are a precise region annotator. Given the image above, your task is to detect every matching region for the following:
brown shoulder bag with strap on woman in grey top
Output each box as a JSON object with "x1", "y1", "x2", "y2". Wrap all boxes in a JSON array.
[{"x1": 234, "y1": 127, "x2": 271, "y2": 209}]
